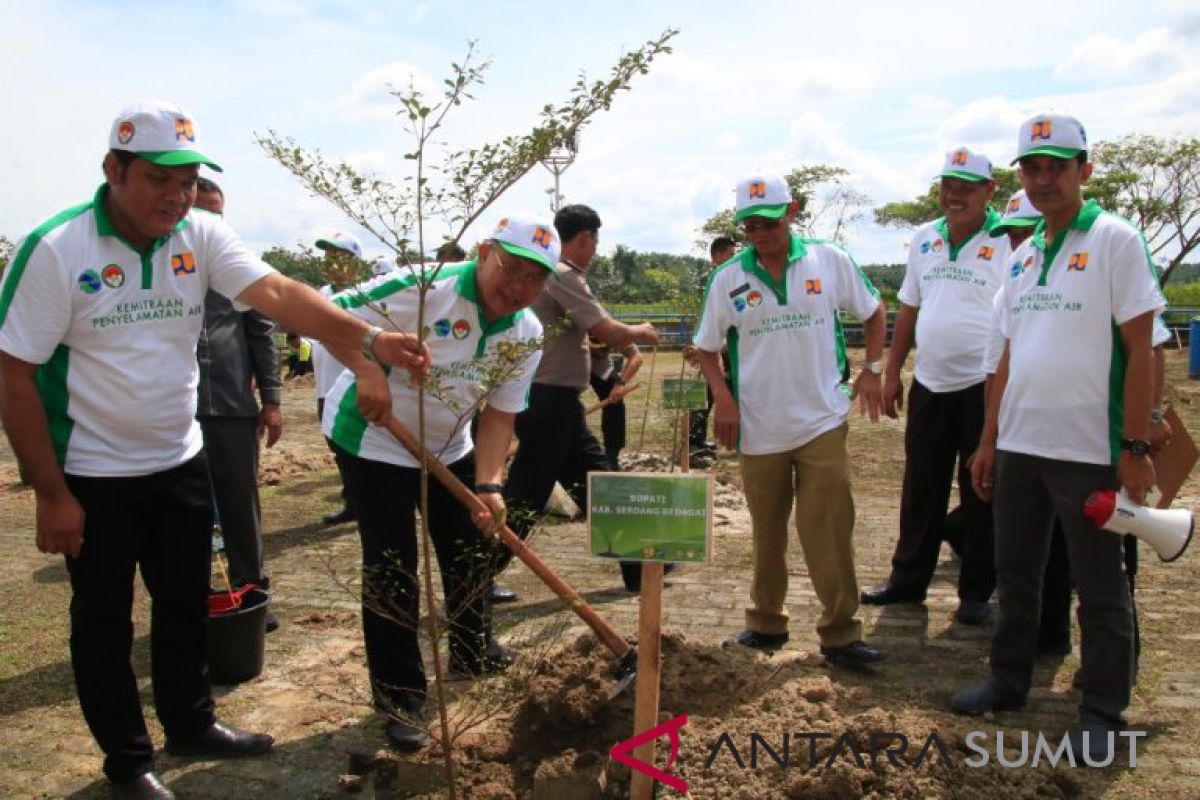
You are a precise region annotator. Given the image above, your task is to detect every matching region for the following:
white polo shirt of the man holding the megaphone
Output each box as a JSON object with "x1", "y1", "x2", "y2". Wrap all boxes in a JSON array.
[{"x1": 996, "y1": 200, "x2": 1165, "y2": 464}]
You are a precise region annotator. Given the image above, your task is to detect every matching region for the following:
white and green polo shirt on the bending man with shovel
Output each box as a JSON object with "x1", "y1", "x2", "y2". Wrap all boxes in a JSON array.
[{"x1": 322, "y1": 261, "x2": 542, "y2": 467}]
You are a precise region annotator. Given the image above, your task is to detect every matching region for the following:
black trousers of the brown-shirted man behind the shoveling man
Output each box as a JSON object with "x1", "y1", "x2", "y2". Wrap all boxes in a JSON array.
[{"x1": 496, "y1": 383, "x2": 642, "y2": 589}]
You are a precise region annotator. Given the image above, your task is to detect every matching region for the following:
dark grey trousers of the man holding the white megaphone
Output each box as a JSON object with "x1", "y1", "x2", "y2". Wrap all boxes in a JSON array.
[{"x1": 991, "y1": 451, "x2": 1133, "y2": 724}]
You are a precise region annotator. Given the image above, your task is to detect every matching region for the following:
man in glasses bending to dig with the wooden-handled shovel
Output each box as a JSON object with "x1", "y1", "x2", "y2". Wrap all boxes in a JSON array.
[{"x1": 323, "y1": 217, "x2": 559, "y2": 750}]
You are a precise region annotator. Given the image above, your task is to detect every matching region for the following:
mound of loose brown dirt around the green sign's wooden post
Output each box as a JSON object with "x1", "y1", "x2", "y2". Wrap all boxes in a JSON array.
[{"x1": 432, "y1": 636, "x2": 1080, "y2": 800}]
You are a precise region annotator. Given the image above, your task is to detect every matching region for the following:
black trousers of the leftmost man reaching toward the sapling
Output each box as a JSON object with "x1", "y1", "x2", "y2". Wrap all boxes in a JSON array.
[{"x1": 66, "y1": 455, "x2": 214, "y2": 782}]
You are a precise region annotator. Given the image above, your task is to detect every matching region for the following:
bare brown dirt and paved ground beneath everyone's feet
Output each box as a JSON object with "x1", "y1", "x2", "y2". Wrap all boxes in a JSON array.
[{"x1": 0, "y1": 351, "x2": 1200, "y2": 799}]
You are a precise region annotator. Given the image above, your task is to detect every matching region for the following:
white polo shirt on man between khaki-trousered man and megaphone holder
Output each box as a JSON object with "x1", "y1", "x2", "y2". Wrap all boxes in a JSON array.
[{"x1": 896, "y1": 207, "x2": 1010, "y2": 392}]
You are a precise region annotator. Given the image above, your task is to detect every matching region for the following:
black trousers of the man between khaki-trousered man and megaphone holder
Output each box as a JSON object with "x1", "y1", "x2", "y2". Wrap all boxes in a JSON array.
[{"x1": 888, "y1": 379, "x2": 996, "y2": 602}]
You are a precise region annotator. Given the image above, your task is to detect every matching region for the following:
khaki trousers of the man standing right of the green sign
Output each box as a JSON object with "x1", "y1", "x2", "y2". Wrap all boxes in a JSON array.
[{"x1": 740, "y1": 423, "x2": 863, "y2": 648}]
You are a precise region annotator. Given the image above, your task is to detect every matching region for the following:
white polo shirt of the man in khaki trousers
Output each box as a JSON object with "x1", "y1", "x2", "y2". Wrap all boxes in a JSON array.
[{"x1": 695, "y1": 235, "x2": 880, "y2": 456}]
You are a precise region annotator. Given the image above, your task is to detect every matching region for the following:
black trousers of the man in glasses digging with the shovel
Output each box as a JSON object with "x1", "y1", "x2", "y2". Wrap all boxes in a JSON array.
[{"x1": 334, "y1": 445, "x2": 494, "y2": 712}]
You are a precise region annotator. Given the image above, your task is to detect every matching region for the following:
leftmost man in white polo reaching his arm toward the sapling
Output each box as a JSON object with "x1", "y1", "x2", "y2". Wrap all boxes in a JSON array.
[{"x1": 0, "y1": 102, "x2": 428, "y2": 798}]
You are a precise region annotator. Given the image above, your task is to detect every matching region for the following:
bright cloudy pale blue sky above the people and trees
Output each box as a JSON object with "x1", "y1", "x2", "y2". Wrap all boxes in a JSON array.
[{"x1": 0, "y1": 0, "x2": 1200, "y2": 263}]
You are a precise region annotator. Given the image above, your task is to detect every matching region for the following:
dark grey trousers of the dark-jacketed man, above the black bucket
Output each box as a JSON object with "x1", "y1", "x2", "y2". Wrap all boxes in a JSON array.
[{"x1": 199, "y1": 416, "x2": 265, "y2": 585}]
